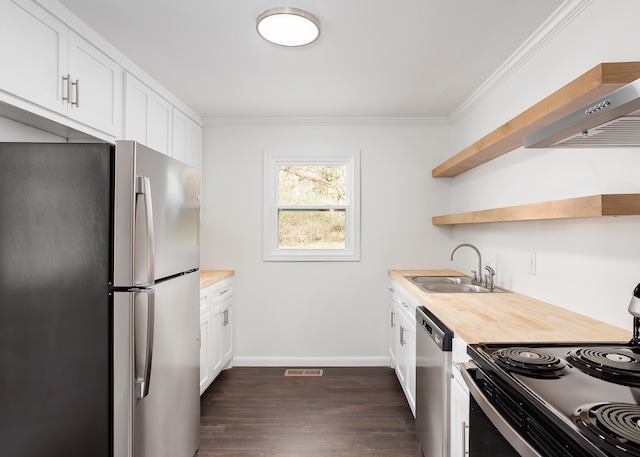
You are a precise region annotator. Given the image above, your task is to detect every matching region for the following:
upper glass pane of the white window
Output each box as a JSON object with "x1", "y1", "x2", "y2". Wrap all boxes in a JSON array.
[{"x1": 278, "y1": 165, "x2": 347, "y2": 205}]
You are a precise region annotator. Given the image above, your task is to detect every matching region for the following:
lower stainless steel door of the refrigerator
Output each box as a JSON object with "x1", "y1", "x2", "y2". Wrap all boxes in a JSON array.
[{"x1": 114, "y1": 272, "x2": 200, "y2": 457}]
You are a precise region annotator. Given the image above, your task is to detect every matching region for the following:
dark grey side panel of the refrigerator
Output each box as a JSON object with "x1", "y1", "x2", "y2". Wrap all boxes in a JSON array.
[{"x1": 0, "y1": 143, "x2": 111, "y2": 457}]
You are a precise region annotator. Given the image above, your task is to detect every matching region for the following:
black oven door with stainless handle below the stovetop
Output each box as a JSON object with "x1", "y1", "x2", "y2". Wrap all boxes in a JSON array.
[{"x1": 460, "y1": 363, "x2": 544, "y2": 457}]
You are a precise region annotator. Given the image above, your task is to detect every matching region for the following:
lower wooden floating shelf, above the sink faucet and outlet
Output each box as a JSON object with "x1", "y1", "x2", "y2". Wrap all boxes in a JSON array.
[{"x1": 432, "y1": 194, "x2": 640, "y2": 225}]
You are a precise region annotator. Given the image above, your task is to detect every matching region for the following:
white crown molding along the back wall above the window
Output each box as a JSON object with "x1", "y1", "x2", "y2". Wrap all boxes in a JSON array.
[{"x1": 202, "y1": 117, "x2": 451, "y2": 127}]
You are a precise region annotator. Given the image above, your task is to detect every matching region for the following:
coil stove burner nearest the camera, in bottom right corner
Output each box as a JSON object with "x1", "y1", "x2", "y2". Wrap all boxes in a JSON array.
[{"x1": 574, "y1": 403, "x2": 640, "y2": 456}]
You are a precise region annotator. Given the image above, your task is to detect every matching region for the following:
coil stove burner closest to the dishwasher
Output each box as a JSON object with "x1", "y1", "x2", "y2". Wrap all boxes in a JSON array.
[{"x1": 491, "y1": 347, "x2": 565, "y2": 377}]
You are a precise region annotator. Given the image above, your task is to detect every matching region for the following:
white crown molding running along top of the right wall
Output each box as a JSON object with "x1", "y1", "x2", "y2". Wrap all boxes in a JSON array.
[{"x1": 449, "y1": 0, "x2": 595, "y2": 123}]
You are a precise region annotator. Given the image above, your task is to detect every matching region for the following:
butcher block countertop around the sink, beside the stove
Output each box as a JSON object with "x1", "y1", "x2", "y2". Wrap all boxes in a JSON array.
[{"x1": 389, "y1": 270, "x2": 633, "y2": 344}]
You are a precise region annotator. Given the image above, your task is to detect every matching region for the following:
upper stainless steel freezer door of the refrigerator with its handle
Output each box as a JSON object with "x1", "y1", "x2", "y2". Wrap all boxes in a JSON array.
[{"x1": 114, "y1": 141, "x2": 200, "y2": 287}]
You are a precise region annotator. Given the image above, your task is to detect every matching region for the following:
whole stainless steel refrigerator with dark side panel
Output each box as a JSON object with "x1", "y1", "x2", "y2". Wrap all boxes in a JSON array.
[{"x1": 0, "y1": 141, "x2": 200, "y2": 457}]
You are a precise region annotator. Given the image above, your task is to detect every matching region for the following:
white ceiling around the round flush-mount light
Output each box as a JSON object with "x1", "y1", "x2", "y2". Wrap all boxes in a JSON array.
[{"x1": 60, "y1": 0, "x2": 562, "y2": 118}]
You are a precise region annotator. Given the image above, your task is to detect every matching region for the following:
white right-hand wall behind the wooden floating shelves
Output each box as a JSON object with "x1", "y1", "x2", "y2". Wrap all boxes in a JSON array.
[{"x1": 448, "y1": 0, "x2": 640, "y2": 329}]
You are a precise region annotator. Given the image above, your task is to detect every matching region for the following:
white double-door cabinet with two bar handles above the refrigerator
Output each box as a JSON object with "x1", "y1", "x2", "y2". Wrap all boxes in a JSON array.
[{"x1": 0, "y1": 0, "x2": 123, "y2": 138}]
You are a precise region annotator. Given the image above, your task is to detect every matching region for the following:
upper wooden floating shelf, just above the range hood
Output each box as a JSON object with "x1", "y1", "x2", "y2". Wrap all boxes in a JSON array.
[{"x1": 431, "y1": 62, "x2": 640, "y2": 178}]
